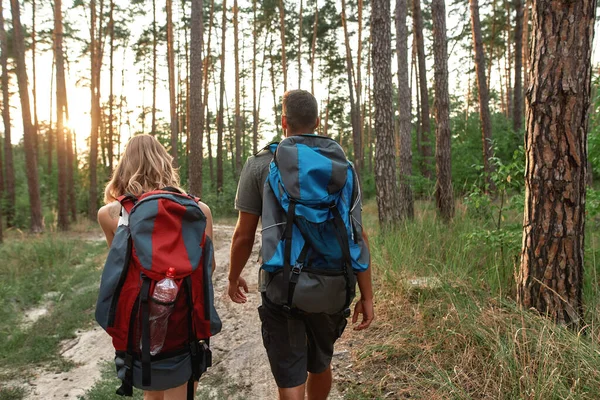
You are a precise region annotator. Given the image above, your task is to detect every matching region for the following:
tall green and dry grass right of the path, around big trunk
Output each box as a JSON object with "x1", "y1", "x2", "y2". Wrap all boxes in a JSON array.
[{"x1": 343, "y1": 204, "x2": 600, "y2": 400}]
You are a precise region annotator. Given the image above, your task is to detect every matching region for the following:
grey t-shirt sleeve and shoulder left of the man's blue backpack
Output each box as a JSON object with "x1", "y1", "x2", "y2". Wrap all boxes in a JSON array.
[{"x1": 235, "y1": 150, "x2": 273, "y2": 216}]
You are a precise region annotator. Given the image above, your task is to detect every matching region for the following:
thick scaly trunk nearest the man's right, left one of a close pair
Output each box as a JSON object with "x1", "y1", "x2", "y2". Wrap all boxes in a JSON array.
[{"x1": 371, "y1": 0, "x2": 400, "y2": 229}]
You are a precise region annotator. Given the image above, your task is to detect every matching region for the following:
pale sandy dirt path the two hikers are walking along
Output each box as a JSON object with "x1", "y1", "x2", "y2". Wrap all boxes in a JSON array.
[{"x1": 0, "y1": 225, "x2": 354, "y2": 400}]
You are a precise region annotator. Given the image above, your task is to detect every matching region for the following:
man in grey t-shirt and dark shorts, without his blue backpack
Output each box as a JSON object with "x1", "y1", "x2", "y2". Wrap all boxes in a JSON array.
[{"x1": 228, "y1": 90, "x2": 374, "y2": 400}]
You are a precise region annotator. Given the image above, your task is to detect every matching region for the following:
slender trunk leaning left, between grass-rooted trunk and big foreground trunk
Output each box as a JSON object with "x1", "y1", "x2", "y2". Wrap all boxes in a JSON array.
[{"x1": 469, "y1": 0, "x2": 493, "y2": 186}]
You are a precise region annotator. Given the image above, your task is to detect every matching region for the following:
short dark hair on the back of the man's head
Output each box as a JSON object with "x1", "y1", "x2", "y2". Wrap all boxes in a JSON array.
[{"x1": 283, "y1": 89, "x2": 319, "y2": 131}]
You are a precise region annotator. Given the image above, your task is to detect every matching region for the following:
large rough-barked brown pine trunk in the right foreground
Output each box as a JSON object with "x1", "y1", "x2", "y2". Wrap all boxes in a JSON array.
[{"x1": 517, "y1": 0, "x2": 596, "y2": 327}]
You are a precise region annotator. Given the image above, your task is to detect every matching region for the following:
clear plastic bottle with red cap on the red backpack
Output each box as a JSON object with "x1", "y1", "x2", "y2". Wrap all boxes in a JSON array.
[{"x1": 150, "y1": 267, "x2": 178, "y2": 356}]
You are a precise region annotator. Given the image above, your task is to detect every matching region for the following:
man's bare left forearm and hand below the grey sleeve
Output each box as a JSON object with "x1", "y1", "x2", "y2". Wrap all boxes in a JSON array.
[{"x1": 227, "y1": 211, "x2": 260, "y2": 303}]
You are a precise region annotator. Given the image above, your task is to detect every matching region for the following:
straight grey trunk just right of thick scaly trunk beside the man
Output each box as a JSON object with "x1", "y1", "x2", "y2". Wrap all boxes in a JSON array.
[{"x1": 394, "y1": 0, "x2": 414, "y2": 219}]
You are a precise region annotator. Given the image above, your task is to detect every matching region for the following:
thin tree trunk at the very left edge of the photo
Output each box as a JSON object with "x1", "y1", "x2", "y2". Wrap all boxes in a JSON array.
[{"x1": 0, "y1": 0, "x2": 16, "y2": 226}]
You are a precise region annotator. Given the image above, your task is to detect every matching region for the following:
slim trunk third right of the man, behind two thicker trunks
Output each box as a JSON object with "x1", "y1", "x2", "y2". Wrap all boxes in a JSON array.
[{"x1": 412, "y1": 0, "x2": 432, "y2": 178}]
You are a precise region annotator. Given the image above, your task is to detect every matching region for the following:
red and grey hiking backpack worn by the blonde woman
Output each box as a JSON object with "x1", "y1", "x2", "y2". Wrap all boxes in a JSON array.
[{"x1": 96, "y1": 188, "x2": 221, "y2": 400}]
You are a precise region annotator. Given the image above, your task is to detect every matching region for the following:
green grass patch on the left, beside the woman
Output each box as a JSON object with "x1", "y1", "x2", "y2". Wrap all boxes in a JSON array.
[{"x1": 0, "y1": 234, "x2": 106, "y2": 384}]
